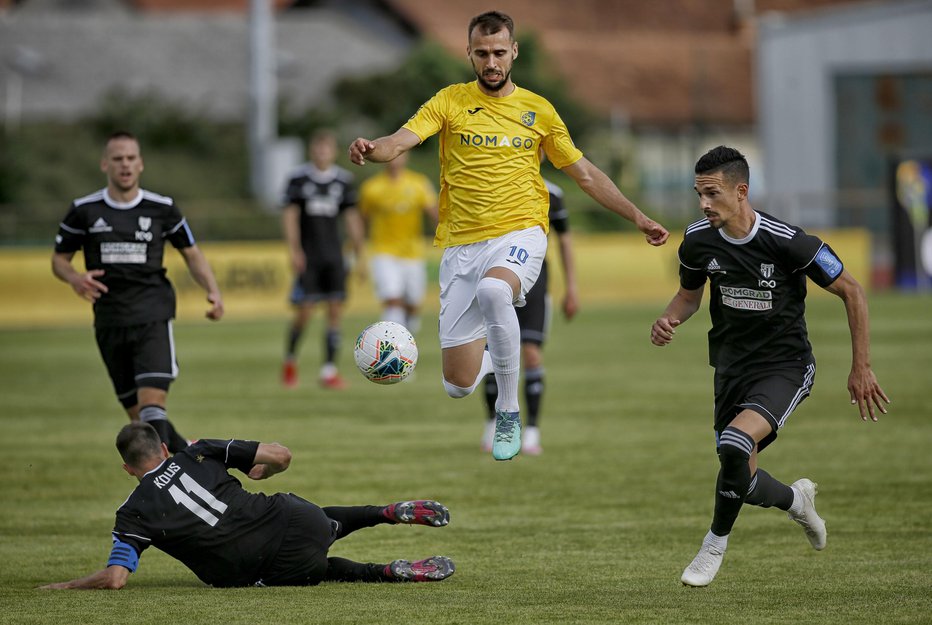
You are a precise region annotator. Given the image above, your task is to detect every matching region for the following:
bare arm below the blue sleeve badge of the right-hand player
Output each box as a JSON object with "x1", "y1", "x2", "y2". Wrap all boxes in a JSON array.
[{"x1": 825, "y1": 270, "x2": 890, "y2": 421}]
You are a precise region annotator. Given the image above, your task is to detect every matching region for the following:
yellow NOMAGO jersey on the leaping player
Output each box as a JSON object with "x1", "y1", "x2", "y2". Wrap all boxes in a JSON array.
[{"x1": 403, "y1": 82, "x2": 582, "y2": 247}]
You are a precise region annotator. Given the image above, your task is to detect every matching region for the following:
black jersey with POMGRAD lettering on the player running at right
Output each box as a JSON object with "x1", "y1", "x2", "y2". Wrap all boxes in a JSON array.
[{"x1": 679, "y1": 212, "x2": 844, "y2": 373}]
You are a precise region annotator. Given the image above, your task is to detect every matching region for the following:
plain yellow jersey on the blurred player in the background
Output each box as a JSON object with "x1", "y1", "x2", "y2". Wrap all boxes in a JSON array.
[{"x1": 359, "y1": 169, "x2": 437, "y2": 259}]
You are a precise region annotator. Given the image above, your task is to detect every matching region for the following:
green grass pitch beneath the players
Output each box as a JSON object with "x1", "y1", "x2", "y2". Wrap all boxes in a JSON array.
[{"x1": 0, "y1": 295, "x2": 932, "y2": 625}]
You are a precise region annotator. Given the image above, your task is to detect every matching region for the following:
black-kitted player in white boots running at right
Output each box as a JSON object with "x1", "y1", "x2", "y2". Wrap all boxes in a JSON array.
[{"x1": 651, "y1": 146, "x2": 889, "y2": 586}]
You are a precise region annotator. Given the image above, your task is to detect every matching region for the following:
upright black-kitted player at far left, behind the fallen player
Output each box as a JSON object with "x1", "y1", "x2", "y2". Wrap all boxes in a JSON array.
[{"x1": 52, "y1": 132, "x2": 223, "y2": 451}]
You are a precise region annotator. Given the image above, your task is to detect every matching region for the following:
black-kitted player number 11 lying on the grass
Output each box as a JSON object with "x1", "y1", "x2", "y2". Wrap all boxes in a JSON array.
[{"x1": 43, "y1": 423, "x2": 455, "y2": 589}]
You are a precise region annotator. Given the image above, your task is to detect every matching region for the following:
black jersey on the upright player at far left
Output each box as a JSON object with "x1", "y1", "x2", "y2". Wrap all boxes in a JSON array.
[{"x1": 55, "y1": 189, "x2": 194, "y2": 326}]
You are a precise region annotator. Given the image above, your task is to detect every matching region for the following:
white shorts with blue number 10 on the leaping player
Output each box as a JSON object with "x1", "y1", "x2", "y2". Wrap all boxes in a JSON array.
[{"x1": 440, "y1": 226, "x2": 547, "y2": 348}]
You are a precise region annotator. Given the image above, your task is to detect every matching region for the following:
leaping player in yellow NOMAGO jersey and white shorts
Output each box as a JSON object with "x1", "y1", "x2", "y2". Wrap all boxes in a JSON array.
[{"x1": 349, "y1": 11, "x2": 670, "y2": 460}]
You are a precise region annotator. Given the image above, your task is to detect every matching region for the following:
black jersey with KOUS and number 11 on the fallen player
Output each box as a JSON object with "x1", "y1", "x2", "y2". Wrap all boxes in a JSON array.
[{"x1": 113, "y1": 440, "x2": 290, "y2": 586}]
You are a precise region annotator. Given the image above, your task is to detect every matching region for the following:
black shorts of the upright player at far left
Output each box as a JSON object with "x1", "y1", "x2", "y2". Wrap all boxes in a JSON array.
[{"x1": 95, "y1": 319, "x2": 178, "y2": 408}]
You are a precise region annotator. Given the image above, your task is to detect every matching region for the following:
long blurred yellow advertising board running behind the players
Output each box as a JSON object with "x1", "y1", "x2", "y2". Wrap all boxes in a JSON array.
[{"x1": 0, "y1": 229, "x2": 870, "y2": 327}]
